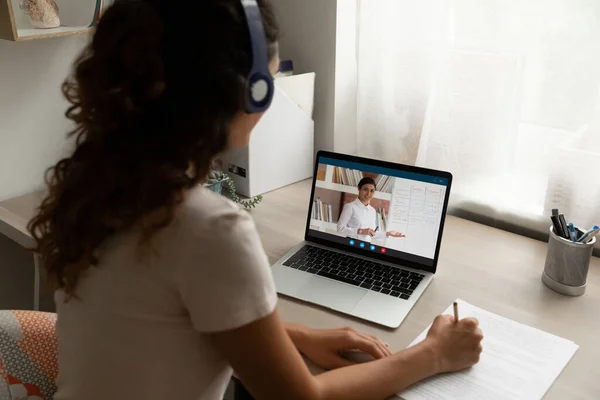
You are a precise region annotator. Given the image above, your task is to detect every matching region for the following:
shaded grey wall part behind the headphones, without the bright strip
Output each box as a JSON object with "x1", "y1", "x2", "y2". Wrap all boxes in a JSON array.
[{"x1": 272, "y1": 0, "x2": 338, "y2": 150}]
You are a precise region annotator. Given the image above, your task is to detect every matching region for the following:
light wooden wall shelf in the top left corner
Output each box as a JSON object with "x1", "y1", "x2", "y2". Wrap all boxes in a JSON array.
[{"x1": 0, "y1": 0, "x2": 94, "y2": 42}]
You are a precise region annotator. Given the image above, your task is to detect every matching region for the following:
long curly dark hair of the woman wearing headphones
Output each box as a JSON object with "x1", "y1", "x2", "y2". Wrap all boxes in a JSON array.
[{"x1": 28, "y1": 0, "x2": 278, "y2": 297}]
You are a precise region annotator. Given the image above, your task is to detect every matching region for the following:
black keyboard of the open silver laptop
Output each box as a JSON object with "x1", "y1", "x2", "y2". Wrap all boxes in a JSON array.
[{"x1": 283, "y1": 246, "x2": 425, "y2": 300}]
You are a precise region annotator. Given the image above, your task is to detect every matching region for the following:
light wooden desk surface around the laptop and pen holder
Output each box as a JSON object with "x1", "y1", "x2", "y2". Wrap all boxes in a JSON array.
[{"x1": 0, "y1": 181, "x2": 600, "y2": 400}]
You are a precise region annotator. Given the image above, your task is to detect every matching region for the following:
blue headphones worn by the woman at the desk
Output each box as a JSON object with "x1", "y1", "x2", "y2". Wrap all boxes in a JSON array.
[{"x1": 241, "y1": 0, "x2": 274, "y2": 114}]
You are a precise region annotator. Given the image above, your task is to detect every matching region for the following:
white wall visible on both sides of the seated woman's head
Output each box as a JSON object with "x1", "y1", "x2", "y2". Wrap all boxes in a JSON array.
[{"x1": 0, "y1": 0, "x2": 356, "y2": 201}]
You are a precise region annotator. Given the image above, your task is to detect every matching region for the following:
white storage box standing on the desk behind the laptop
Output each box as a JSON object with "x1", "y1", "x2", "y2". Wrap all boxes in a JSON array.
[{"x1": 221, "y1": 73, "x2": 315, "y2": 197}]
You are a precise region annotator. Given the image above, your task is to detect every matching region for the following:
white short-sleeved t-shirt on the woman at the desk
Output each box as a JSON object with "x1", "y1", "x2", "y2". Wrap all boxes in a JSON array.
[{"x1": 54, "y1": 188, "x2": 277, "y2": 400}]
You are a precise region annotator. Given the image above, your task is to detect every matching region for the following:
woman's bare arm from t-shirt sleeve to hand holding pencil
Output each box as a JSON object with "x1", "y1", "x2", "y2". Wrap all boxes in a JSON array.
[{"x1": 213, "y1": 312, "x2": 481, "y2": 400}]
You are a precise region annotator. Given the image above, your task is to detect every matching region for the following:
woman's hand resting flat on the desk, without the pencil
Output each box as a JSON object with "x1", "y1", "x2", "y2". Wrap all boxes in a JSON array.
[{"x1": 286, "y1": 324, "x2": 392, "y2": 369}]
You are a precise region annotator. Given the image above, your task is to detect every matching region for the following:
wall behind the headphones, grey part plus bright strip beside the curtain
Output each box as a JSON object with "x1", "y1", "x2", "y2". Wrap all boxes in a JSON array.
[{"x1": 273, "y1": 0, "x2": 358, "y2": 154}]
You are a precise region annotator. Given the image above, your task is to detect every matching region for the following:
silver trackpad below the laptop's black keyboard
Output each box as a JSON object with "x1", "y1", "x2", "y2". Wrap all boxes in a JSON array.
[{"x1": 298, "y1": 276, "x2": 367, "y2": 313}]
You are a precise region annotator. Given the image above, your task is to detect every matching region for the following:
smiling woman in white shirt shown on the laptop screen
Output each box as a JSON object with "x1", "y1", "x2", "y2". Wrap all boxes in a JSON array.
[{"x1": 338, "y1": 177, "x2": 404, "y2": 241}]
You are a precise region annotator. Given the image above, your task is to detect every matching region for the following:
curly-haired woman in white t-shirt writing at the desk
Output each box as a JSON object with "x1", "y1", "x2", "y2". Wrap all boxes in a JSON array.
[{"x1": 29, "y1": 0, "x2": 481, "y2": 400}]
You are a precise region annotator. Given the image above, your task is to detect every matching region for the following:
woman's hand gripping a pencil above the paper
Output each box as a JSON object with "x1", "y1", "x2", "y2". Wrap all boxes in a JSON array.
[{"x1": 425, "y1": 315, "x2": 483, "y2": 373}]
